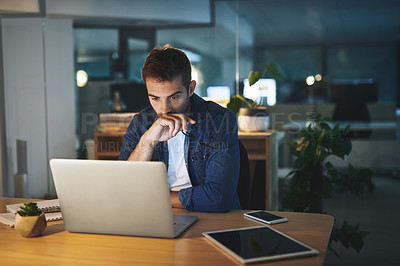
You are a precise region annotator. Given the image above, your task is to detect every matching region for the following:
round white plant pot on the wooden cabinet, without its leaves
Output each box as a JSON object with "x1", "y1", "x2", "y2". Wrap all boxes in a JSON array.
[{"x1": 238, "y1": 108, "x2": 269, "y2": 132}]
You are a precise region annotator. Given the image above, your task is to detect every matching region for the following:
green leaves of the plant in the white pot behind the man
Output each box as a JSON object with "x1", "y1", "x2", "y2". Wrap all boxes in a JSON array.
[{"x1": 227, "y1": 62, "x2": 282, "y2": 115}]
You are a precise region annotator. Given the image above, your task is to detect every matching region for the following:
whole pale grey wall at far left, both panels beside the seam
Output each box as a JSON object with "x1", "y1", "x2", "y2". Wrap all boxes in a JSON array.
[{"x1": 2, "y1": 18, "x2": 75, "y2": 198}]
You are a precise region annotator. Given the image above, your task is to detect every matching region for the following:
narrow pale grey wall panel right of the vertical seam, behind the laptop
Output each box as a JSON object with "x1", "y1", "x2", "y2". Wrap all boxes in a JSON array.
[{"x1": 45, "y1": 19, "x2": 76, "y2": 195}]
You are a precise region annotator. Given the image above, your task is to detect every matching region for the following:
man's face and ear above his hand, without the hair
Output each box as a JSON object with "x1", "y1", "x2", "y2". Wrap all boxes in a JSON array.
[{"x1": 146, "y1": 77, "x2": 196, "y2": 116}]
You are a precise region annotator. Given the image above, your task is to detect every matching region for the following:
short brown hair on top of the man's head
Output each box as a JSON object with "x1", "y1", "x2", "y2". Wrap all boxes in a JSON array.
[{"x1": 142, "y1": 44, "x2": 192, "y2": 89}]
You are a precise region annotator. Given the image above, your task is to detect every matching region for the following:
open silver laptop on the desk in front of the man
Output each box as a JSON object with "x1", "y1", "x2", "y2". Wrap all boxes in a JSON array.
[{"x1": 50, "y1": 159, "x2": 198, "y2": 238}]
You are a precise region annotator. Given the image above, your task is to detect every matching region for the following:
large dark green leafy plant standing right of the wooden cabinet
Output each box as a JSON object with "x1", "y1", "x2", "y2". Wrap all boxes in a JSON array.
[{"x1": 283, "y1": 114, "x2": 372, "y2": 255}]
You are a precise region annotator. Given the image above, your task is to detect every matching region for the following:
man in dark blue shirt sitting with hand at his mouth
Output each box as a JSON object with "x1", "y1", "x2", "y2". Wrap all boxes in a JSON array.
[{"x1": 119, "y1": 46, "x2": 241, "y2": 212}]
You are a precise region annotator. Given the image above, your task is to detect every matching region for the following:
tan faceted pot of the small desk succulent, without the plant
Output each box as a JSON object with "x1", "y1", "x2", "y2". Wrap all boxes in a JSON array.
[{"x1": 15, "y1": 212, "x2": 47, "y2": 237}]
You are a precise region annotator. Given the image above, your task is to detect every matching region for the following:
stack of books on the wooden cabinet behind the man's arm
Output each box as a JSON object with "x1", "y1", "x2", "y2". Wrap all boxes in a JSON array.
[{"x1": 97, "y1": 113, "x2": 136, "y2": 133}]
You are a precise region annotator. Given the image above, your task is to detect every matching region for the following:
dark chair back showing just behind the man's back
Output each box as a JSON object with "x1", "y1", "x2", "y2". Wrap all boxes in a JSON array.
[{"x1": 237, "y1": 140, "x2": 251, "y2": 209}]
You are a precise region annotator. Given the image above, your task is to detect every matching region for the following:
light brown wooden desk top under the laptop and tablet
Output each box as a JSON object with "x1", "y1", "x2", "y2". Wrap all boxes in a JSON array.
[{"x1": 0, "y1": 198, "x2": 333, "y2": 266}]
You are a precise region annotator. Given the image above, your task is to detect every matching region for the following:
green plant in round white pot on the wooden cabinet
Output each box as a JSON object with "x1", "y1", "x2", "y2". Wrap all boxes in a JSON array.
[{"x1": 227, "y1": 62, "x2": 282, "y2": 132}]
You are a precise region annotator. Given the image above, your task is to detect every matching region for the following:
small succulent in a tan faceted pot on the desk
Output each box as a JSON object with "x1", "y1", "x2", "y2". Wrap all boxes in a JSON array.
[{"x1": 15, "y1": 202, "x2": 47, "y2": 237}]
